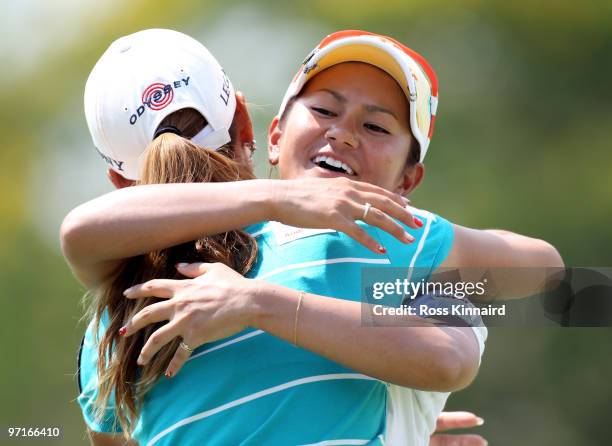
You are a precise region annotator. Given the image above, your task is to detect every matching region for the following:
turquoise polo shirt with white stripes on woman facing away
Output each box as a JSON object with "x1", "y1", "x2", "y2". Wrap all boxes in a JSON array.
[{"x1": 78, "y1": 209, "x2": 462, "y2": 446}]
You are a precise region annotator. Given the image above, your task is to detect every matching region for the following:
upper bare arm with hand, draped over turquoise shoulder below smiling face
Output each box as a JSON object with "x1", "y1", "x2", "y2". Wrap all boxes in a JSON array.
[{"x1": 60, "y1": 178, "x2": 418, "y2": 288}]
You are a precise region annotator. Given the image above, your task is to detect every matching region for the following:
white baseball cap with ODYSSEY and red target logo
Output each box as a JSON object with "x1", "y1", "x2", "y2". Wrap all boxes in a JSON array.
[{"x1": 85, "y1": 29, "x2": 236, "y2": 180}]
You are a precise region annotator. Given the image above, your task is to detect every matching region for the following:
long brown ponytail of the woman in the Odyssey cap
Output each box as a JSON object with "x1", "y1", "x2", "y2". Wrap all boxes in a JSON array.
[{"x1": 90, "y1": 109, "x2": 257, "y2": 438}]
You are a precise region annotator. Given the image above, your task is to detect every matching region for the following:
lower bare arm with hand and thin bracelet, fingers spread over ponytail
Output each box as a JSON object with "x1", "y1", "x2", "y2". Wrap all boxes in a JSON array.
[{"x1": 125, "y1": 263, "x2": 480, "y2": 391}]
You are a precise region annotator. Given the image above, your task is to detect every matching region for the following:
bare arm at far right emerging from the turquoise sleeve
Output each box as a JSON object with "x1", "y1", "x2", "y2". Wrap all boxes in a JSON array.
[{"x1": 440, "y1": 225, "x2": 564, "y2": 298}]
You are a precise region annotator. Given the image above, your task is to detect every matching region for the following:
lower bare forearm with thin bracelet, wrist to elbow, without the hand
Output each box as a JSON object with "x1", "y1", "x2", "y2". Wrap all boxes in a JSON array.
[{"x1": 253, "y1": 282, "x2": 479, "y2": 392}]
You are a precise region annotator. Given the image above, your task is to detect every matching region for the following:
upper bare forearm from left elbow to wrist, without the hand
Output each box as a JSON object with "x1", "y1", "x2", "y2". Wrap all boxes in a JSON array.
[{"x1": 60, "y1": 182, "x2": 268, "y2": 287}]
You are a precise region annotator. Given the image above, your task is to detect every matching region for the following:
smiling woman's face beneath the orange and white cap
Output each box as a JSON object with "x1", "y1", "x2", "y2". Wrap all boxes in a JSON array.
[{"x1": 269, "y1": 62, "x2": 423, "y2": 193}]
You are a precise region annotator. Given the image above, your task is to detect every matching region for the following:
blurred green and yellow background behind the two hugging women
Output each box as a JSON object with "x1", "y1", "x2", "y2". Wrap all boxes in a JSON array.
[{"x1": 0, "y1": 0, "x2": 612, "y2": 446}]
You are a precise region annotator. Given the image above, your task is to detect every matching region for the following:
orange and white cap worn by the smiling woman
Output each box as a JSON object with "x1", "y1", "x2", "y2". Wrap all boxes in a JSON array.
[{"x1": 278, "y1": 30, "x2": 438, "y2": 162}]
